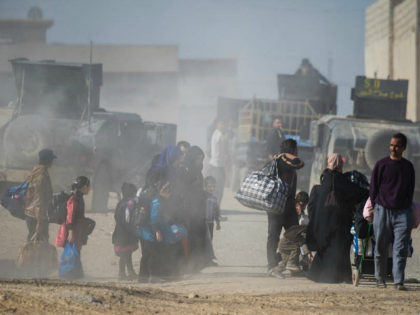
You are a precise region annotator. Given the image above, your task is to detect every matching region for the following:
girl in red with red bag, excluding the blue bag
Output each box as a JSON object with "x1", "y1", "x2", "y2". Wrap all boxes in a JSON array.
[{"x1": 55, "y1": 176, "x2": 95, "y2": 278}]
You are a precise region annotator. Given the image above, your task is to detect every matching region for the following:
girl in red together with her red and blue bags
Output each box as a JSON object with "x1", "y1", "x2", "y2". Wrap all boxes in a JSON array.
[{"x1": 55, "y1": 176, "x2": 95, "y2": 279}]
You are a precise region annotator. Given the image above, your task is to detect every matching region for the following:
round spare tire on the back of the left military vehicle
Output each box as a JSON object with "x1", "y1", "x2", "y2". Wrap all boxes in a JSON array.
[{"x1": 3, "y1": 116, "x2": 52, "y2": 167}]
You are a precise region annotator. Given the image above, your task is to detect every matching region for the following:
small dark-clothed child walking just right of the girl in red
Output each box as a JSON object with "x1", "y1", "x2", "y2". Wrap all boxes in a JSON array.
[{"x1": 112, "y1": 183, "x2": 139, "y2": 280}]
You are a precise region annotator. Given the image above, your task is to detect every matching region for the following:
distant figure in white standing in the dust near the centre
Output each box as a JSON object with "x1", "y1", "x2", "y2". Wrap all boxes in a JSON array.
[{"x1": 209, "y1": 120, "x2": 228, "y2": 205}]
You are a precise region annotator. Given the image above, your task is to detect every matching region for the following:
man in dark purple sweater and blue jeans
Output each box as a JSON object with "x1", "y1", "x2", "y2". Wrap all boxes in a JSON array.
[{"x1": 370, "y1": 133, "x2": 415, "y2": 290}]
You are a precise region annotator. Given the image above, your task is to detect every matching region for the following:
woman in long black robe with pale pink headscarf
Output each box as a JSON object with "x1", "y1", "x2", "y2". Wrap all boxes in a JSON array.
[{"x1": 307, "y1": 153, "x2": 368, "y2": 283}]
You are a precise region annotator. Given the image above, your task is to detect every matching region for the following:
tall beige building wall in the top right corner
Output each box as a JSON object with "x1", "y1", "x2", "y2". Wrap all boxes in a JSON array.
[{"x1": 365, "y1": 0, "x2": 420, "y2": 121}]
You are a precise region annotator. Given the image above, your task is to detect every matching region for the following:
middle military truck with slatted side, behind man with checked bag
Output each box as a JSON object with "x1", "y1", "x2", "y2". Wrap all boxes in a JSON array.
[{"x1": 209, "y1": 59, "x2": 337, "y2": 191}]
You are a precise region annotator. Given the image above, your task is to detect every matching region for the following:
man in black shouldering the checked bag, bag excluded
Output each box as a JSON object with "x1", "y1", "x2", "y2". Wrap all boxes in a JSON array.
[{"x1": 267, "y1": 139, "x2": 304, "y2": 278}]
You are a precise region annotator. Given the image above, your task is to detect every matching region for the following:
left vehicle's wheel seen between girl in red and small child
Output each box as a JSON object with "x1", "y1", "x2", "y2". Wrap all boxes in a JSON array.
[{"x1": 92, "y1": 164, "x2": 111, "y2": 213}]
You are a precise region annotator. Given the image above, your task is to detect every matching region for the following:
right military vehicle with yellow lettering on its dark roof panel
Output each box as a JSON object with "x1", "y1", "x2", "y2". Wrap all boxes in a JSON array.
[{"x1": 310, "y1": 76, "x2": 420, "y2": 198}]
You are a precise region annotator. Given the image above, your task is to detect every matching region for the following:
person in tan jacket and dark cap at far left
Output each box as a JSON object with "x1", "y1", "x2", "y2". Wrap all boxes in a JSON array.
[{"x1": 25, "y1": 149, "x2": 57, "y2": 241}]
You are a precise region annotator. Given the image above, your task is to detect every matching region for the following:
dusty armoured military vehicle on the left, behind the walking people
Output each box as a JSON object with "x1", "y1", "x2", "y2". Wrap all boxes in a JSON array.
[{"x1": 0, "y1": 59, "x2": 176, "y2": 211}]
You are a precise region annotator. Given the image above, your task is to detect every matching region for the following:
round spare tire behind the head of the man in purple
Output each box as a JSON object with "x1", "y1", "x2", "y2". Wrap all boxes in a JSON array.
[{"x1": 365, "y1": 130, "x2": 410, "y2": 170}]
